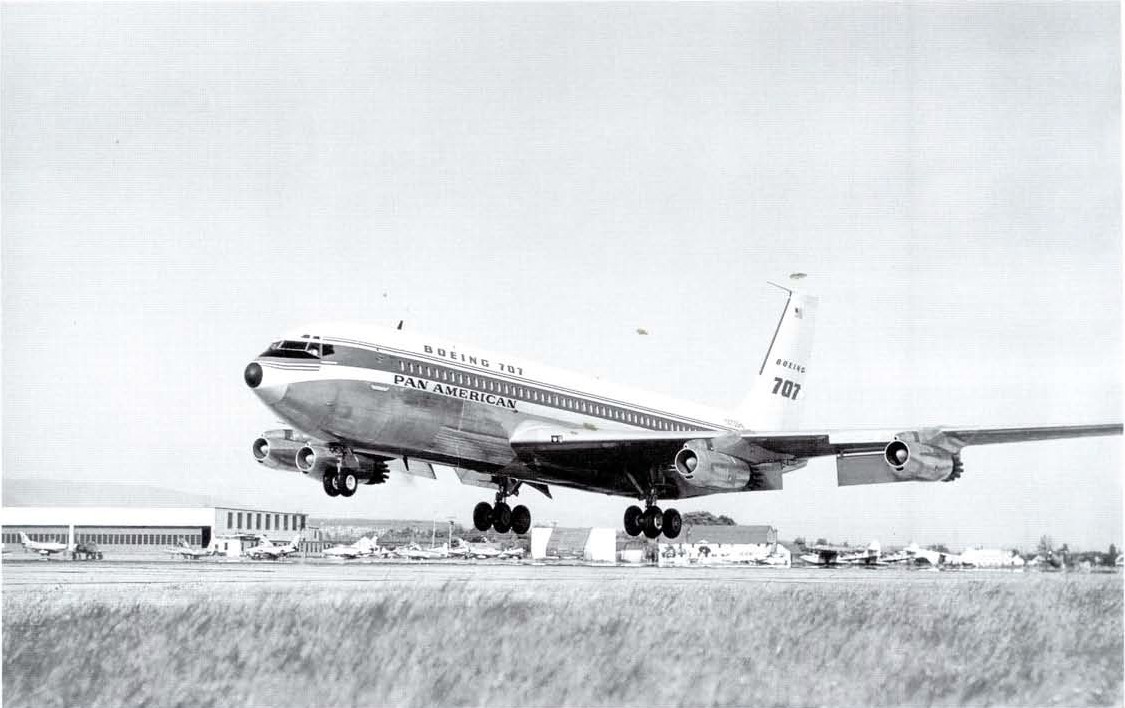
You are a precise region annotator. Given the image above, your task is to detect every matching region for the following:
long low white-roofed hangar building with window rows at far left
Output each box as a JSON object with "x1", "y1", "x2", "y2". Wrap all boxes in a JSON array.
[{"x1": 2, "y1": 507, "x2": 321, "y2": 552}]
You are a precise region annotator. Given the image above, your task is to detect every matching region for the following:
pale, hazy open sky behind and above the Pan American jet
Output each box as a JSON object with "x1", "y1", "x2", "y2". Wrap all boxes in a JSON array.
[{"x1": 0, "y1": 2, "x2": 1122, "y2": 549}]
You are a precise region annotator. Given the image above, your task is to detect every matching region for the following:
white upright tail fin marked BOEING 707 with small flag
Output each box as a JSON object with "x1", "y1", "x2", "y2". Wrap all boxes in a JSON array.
[{"x1": 735, "y1": 286, "x2": 817, "y2": 430}]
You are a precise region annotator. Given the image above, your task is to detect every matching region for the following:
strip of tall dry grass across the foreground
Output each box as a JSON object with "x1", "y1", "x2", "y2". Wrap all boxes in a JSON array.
[{"x1": 3, "y1": 574, "x2": 1125, "y2": 707}]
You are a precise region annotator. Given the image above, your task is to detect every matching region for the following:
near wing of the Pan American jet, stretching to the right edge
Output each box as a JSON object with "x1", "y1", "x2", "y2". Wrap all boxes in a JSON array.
[{"x1": 510, "y1": 423, "x2": 1122, "y2": 499}]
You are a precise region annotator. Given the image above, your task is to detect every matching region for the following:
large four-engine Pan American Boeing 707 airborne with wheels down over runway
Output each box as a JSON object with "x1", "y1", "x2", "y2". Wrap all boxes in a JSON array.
[{"x1": 243, "y1": 281, "x2": 1122, "y2": 538}]
